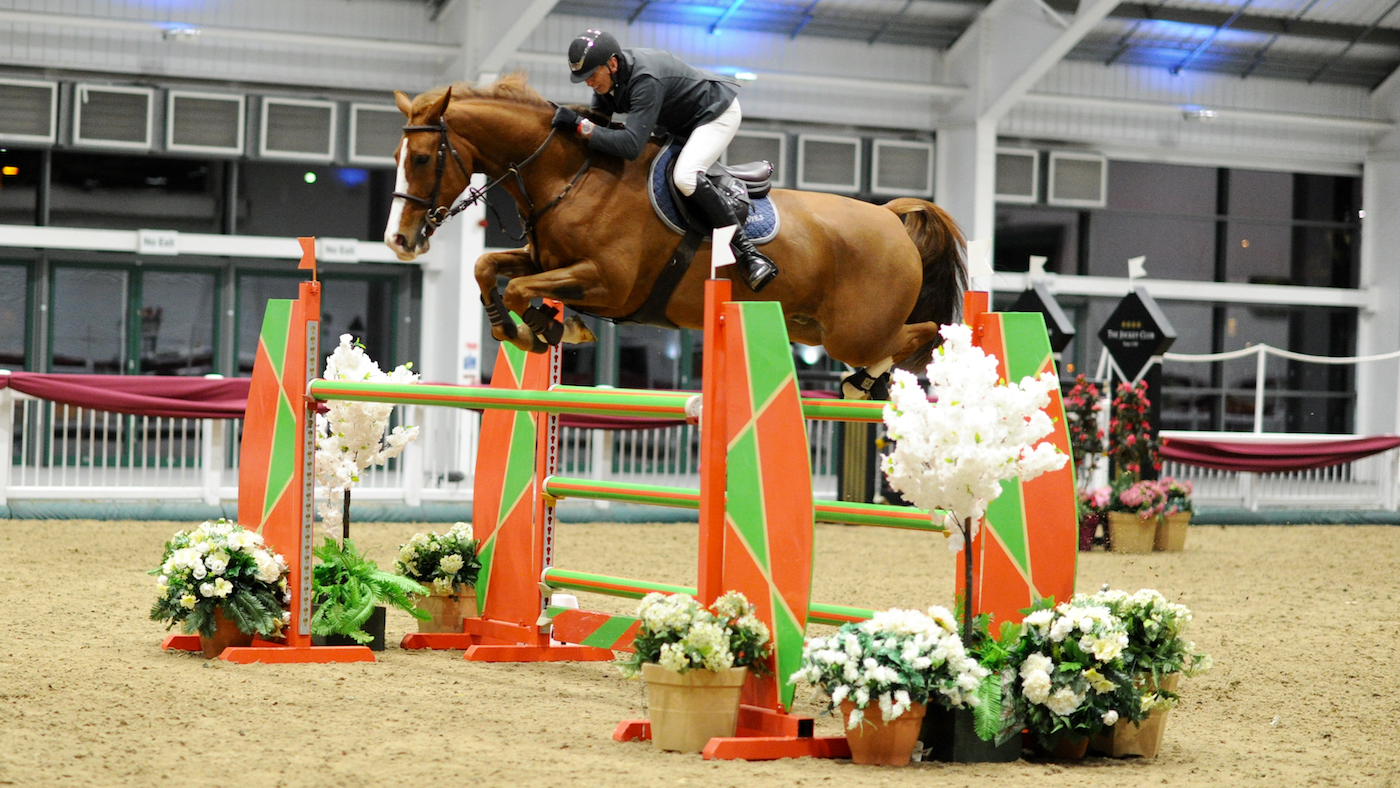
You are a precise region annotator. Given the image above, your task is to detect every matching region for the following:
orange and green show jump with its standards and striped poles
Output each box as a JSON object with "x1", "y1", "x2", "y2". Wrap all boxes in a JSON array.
[{"x1": 191, "y1": 247, "x2": 1077, "y2": 760}]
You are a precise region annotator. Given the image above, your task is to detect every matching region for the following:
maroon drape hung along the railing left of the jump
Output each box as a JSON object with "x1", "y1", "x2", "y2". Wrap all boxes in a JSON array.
[{"x1": 0, "y1": 372, "x2": 251, "y2": 418}]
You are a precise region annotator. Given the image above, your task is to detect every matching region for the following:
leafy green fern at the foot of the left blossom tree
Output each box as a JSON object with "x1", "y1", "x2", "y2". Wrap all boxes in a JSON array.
[{"x1": 311, "y1": 537, "x2": 431, "y2": 644}]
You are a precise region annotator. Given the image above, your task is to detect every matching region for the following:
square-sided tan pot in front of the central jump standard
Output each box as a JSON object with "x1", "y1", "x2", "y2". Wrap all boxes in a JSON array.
[{"x1": 641, "y1": 662, "x2": 749, "y2": 753}]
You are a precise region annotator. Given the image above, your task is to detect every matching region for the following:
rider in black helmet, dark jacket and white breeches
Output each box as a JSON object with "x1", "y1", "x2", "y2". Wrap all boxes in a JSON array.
[{"x1": 554, "y1": 29, "x2": 778, "y2": 293}]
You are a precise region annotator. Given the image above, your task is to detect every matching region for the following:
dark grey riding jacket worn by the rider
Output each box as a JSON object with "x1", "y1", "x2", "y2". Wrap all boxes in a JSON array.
[{"x1": 588, "y1": 49, "x2": 739, "y2": 160}]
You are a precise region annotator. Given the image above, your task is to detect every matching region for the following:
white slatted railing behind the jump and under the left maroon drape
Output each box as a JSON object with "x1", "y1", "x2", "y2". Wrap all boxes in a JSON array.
[{"x1": 0, "y1": 388, "x2": 839, "y2": 505}]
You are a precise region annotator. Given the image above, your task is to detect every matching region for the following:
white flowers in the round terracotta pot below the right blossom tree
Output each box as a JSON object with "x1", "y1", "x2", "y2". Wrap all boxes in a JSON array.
[{"x1": 792, "y1": 606, "x2": 987, "y2": 729}]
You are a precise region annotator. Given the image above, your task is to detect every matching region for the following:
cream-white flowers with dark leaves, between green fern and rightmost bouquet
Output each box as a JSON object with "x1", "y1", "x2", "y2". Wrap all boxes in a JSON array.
[{"x1": 1011, "y1": 603, "x2": 1145, "y2": 749}]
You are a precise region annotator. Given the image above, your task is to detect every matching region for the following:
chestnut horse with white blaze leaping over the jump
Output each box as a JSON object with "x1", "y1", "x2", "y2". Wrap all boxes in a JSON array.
[{"x1": 384, "y1": 74, "x2": 967, "y2": 396}]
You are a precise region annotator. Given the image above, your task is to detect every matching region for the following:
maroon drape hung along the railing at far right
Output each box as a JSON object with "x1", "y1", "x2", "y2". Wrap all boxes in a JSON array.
[{"x1": 1161, "y1": 435, "x2": 1400, "y2": 473}]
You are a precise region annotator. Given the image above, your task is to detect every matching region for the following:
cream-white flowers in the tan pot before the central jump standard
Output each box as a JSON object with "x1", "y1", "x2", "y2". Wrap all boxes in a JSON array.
[{"x1": 620, "y1": 591, "x2": 771, "y2": 679}]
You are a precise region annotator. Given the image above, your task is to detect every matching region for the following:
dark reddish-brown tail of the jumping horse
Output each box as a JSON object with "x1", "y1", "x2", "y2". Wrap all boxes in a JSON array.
[{"x1": 885, "y1": 197, "x2": 967, "y2": 371}]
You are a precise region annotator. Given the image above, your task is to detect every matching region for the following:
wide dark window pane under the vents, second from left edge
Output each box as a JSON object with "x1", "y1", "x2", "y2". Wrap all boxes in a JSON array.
[{"x1": 50, "y1": 151, "x2": 224, "y2": 232}]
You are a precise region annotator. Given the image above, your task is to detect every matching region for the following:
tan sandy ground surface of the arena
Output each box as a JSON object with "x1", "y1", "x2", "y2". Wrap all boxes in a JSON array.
[{"x1": 0, "y1": 521, "x2": 1400, "y2": 788}]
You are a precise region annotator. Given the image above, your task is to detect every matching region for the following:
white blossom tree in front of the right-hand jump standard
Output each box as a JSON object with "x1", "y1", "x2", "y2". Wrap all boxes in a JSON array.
[{"x1": 883, "y1": 325, "x2": 1068, "y2": 637}]
